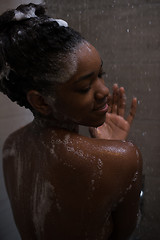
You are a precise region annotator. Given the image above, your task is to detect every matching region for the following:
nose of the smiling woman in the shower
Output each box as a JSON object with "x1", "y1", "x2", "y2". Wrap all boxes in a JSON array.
[{"x1": 95, "y1": 79, "x2": 109, "y2": 101}]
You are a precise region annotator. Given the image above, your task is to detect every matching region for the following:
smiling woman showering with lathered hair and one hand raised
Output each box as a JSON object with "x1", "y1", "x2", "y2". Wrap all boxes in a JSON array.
[{"x1": 0, "y1": 4, "x2": 142, "y2": 240}]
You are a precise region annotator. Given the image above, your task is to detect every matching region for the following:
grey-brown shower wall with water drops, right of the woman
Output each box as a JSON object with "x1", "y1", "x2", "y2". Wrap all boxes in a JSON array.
[{"x1": 46, "y1": 0, "x2": 160, "y2": 240}]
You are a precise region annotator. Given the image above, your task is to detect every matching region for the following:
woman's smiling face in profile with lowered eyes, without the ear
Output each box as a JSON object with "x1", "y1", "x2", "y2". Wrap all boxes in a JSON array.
[{"x1": 50, "y1": 42, "x2": 109, "y2": 127}]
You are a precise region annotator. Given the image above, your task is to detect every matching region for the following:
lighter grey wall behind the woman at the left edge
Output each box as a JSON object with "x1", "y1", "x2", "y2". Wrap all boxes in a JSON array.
[{"x1": 0, "y1": 0, "x2": 42, "y2": 240}]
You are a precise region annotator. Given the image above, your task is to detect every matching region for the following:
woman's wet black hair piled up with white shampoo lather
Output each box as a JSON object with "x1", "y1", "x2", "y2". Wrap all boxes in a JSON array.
[{"x1": 0, "y1": 3, "x2": 84, "y2": 111}]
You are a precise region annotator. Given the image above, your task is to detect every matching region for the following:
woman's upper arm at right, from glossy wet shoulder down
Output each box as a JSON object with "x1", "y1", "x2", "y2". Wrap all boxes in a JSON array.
[{"x1": 72, "y1": 136, "x2": 142, "y2": 240}]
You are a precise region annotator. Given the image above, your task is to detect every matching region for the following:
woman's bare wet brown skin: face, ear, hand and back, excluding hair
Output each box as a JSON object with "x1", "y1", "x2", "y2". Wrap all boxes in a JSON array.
[{"x1": 3, "y1": 43, "x2": 142, "y2": 240}]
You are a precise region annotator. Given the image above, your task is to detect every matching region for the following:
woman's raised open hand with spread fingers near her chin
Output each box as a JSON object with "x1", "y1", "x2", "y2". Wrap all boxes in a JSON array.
[{"x1": 89, "y1": 84, "x2": 137, "y2": 140}]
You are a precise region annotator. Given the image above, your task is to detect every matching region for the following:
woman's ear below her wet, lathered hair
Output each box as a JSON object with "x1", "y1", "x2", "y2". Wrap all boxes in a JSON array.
[{"x1": 27, "y1": 90, "x2": 51, "y2": 116}]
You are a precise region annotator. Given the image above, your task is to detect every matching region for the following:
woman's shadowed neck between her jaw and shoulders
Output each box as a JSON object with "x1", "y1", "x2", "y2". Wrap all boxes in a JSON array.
[{"x1": 33, "y1": 116, "x2": 79, "y2": 133}]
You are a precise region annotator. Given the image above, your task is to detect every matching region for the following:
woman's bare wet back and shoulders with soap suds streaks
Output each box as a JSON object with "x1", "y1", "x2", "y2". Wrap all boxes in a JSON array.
[{"x1": 4, "y1": 124, "x2": 141, "y2": 240}]
